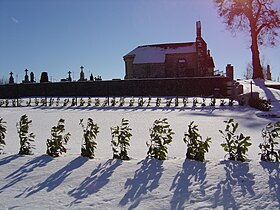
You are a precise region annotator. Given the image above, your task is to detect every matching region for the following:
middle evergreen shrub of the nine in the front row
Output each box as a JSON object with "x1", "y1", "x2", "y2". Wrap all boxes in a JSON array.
[{"x1": 111, "y1": 119, "x2": 132, "y2": 160}]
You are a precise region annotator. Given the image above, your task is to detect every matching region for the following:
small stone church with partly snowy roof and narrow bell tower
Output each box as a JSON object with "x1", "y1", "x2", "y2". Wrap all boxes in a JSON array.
[{"x1": 123, "y1": 21, "x2": 215, "y2": 79}]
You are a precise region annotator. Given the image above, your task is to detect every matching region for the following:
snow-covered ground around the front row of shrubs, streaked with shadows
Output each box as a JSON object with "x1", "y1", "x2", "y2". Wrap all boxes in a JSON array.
[{"x1": 0, "y1": 81, "x2": 280, "y2": 209}]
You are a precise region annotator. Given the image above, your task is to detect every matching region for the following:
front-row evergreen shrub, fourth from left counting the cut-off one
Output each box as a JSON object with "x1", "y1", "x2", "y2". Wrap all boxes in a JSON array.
[{"x1": 80, "y1": 118, "x2": 99, "y2": 159}]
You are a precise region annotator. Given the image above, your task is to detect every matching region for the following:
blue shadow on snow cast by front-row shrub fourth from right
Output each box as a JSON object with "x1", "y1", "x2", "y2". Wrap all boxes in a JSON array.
[{"x1": 119, "y1": 159, "x2": 163, "y2": 209}]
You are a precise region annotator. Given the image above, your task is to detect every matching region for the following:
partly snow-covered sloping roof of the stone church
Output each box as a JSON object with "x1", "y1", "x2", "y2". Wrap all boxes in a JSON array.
[{"x1": 126, "y1": 42, "x2": 196, "y2": 64}]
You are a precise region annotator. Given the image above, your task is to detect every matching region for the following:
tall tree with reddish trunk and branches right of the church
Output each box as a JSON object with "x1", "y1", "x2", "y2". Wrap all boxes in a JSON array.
[{"x1": 213, "y1": 0, "x2": 280, "y2": 79}]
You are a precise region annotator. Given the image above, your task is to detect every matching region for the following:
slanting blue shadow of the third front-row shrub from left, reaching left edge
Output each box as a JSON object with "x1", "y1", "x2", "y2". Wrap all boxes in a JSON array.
[{"x1": 0, "y1": 155, "x2": 53, "y2": 193}]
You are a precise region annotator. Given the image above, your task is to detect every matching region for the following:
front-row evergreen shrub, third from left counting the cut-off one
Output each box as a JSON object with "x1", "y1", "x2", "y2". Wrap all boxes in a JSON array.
[{"x1": 47, "y1": 119, "x2": 71, "y2": 157}]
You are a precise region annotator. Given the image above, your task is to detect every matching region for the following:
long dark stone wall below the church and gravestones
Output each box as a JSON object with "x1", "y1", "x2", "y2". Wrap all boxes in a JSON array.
[{"x1": 0, "y1": 77, "x2": 233, "y2": 98}]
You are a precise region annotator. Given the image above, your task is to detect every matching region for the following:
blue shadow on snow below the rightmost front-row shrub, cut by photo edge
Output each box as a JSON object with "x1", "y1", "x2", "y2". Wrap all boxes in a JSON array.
[{"x1": 260, "y1": 161, "x2": 280, "y2": 207}]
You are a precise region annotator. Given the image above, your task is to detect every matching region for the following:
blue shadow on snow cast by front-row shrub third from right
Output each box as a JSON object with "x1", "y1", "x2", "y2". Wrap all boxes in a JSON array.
[{"x1": 170, "y1": 160, "x2": 206, "y2": 209}]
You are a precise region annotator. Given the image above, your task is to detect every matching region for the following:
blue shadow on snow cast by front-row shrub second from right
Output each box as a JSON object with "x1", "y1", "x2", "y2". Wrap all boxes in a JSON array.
[{"x1": 212, "y1": 160, "x2": 255, "y2": 209}]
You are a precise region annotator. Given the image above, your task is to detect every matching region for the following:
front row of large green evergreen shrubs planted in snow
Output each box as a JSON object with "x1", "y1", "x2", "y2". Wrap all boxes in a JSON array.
[{"x1": 0, "y1": 115, "x2": 280, "y2": 162}]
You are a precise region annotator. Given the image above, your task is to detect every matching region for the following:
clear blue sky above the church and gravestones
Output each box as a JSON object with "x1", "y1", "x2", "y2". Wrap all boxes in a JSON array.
[{"x1": 0, "y1": 0, "x2": 280, "y2": 82}]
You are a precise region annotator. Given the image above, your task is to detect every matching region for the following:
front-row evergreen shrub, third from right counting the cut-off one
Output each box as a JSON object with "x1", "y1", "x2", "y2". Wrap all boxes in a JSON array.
[{"x1": 183, "y1": 121, "x2": 211, "y2": 161}]
